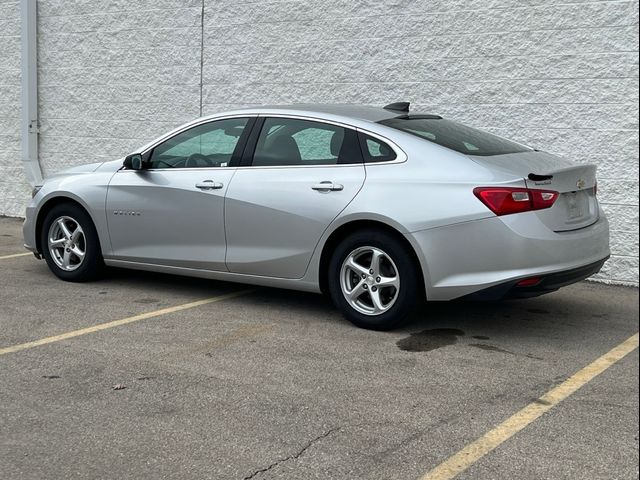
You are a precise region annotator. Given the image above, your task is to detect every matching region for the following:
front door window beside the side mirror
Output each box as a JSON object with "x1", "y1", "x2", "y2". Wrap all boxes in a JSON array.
[{"x1": 149, "y1": 118, "x2": 249, "y2": 168}]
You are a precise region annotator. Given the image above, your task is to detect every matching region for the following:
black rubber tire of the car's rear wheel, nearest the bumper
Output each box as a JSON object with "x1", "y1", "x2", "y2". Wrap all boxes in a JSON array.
[{"x1": 327, "y1": 229, "x2": 422, "y2": 330}]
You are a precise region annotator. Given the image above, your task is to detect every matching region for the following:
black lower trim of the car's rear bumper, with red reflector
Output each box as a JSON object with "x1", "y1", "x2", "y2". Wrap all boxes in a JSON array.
[{"x1": 462, "y1": 256, "x2": 609, "y2": 301}]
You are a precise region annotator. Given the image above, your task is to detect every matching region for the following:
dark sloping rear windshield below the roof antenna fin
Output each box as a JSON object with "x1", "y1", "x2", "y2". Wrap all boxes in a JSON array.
[{"x1": 379, "y1": 117, "x2": 530, "y2": 156}]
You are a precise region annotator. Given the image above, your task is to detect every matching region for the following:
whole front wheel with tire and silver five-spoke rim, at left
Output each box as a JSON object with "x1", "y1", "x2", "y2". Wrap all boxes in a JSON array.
[{"x1": 40, "y1": 204, "x2": 103, "y2": 282}]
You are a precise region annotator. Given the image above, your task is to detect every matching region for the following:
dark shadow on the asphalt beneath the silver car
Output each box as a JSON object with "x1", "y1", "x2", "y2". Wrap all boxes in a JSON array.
[{"x1": 102, "y1": 268, "x2": 624, "y2": 340}]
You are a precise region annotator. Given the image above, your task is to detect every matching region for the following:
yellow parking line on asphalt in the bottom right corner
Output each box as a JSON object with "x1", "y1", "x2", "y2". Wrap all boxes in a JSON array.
[{"x1": 421, "y1": 333, "x2": 638, "y2": 480}]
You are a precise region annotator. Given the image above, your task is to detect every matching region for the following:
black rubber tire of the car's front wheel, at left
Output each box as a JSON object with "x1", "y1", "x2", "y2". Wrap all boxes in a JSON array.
[{"x1": 40, "y1": 203, "x2": 104, "y2": 282}]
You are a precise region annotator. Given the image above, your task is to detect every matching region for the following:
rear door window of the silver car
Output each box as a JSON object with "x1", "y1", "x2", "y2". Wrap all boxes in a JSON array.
[{"x1": 252, "y1": 118, "x2": 362, "y2": 166}]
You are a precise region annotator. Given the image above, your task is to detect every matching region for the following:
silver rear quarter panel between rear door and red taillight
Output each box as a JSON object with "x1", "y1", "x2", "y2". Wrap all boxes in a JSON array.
[{"x1": 341, "y1": 131, "x2": 524, "y2": 232}]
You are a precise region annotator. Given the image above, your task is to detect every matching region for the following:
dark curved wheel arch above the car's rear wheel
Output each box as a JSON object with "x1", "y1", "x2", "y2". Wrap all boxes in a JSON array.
[{"x1": 318, "y1": 219, "x2": 426, "y2": 298}]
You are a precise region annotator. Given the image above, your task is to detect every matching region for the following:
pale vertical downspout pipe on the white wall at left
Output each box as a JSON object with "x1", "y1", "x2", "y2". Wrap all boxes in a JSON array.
[{"x1": 20, "y1": 0, "x2": 42, "y2": 186}]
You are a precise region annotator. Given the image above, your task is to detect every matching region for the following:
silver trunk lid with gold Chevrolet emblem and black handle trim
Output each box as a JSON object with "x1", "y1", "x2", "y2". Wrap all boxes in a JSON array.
[{"x1": 470, "y1": 151, "x2": 599, "y2": 232}]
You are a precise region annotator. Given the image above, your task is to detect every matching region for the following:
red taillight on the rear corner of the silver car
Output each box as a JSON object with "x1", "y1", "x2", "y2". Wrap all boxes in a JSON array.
[{"x1": 473, "y1": 187, "x2": 560, "y2": 216}]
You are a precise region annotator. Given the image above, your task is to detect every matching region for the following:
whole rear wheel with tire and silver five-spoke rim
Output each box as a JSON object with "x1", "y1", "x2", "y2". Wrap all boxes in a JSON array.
[{"x1": 329, "y1": 230, "x2": 419, "y2": 330}]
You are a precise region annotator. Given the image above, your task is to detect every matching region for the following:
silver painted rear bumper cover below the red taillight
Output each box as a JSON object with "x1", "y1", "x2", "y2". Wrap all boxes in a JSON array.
[{"x1": 407, "y1": 212, "x2": 610, "y2": 300}]
